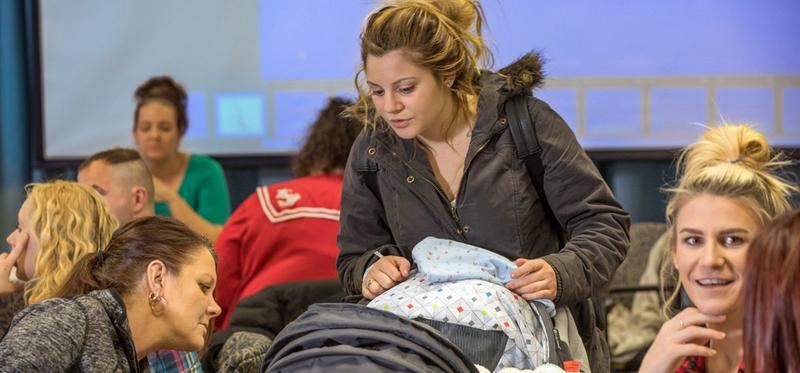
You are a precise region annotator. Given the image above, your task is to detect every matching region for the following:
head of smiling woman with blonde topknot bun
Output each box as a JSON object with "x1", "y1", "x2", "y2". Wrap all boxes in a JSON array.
[{"x1": 667, "y1": 125, "x2": 796, "y2": 320}]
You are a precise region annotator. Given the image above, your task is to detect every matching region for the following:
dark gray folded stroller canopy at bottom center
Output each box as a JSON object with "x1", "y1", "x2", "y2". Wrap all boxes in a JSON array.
[{"x1": 261, "y1": 303, "x2": 477, "y2": 373}]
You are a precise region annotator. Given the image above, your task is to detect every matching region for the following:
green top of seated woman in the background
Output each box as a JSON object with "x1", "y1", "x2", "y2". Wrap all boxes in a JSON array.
[{"x1": 156, "y1": 154, "x2": 231, "y2": 225}]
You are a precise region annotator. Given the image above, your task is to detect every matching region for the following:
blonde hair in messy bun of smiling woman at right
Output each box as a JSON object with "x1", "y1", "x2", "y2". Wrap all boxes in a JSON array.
[{"x1": 662, "y1": 125, "x2": 798, "y2": 316}]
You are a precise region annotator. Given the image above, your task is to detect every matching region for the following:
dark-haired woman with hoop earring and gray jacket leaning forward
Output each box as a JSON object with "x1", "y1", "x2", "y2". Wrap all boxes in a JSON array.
[{"x1": 0, "y1": 217, "x2": 220, "y2": 372}]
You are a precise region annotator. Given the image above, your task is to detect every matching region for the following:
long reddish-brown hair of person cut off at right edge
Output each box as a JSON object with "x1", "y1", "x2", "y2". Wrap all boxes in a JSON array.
[{"x1": 744, "y1": 209, "x2": 800, "y2": 372}]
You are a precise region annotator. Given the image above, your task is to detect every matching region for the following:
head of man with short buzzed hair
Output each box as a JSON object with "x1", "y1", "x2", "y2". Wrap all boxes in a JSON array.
[{"x1": 78, "y1": 148, "x2": 155, "y2": 224}]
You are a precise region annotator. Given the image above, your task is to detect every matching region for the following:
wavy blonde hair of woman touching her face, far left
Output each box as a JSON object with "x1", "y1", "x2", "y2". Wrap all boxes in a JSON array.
[{"x1": 25, "y1": 180, "x2": 118, "y2": 304}]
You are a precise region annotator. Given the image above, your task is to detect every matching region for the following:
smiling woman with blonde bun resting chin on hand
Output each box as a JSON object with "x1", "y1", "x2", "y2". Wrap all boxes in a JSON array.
[{"x1": 641, "y1": 125, "x2": 797, "y2": 373}]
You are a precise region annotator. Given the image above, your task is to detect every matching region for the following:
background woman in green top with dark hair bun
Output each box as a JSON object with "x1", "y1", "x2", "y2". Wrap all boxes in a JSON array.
[{"x1": 133, "y1": 76, "x2": 231, "y2": 242}]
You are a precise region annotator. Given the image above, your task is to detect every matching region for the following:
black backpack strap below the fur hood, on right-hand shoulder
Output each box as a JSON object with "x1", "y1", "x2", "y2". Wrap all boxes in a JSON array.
[{"x1": 505, "y1": 95, "x2": 566, "y2": 247}]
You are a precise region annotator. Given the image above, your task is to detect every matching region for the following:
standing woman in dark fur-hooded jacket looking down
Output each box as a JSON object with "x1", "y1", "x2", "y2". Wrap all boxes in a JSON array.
[{"x1": 337, "y1": 0, "x2": 629, "y2": 371}]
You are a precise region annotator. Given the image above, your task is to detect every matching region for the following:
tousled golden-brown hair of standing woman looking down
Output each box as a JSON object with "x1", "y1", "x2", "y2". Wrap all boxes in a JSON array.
[{"x1": 347, "y1": 0, "x2": 492, "y2": 131}]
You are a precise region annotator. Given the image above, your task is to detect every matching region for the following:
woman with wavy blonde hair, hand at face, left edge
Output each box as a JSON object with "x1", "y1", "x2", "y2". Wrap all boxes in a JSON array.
[{"x1": 0, "y1": 180, "x2": 118, "y2": 332}]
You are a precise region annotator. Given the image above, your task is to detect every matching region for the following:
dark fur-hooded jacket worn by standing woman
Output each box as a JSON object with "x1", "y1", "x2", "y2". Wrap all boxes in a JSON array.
[{"x1": 337, "y1": 54, "x2": 630, "y2": 372}]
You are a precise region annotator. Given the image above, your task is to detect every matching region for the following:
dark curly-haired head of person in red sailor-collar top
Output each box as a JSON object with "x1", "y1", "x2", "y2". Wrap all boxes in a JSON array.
[{"x1": 292, "y1": 97, "x2": 363, "y2": 177}]
